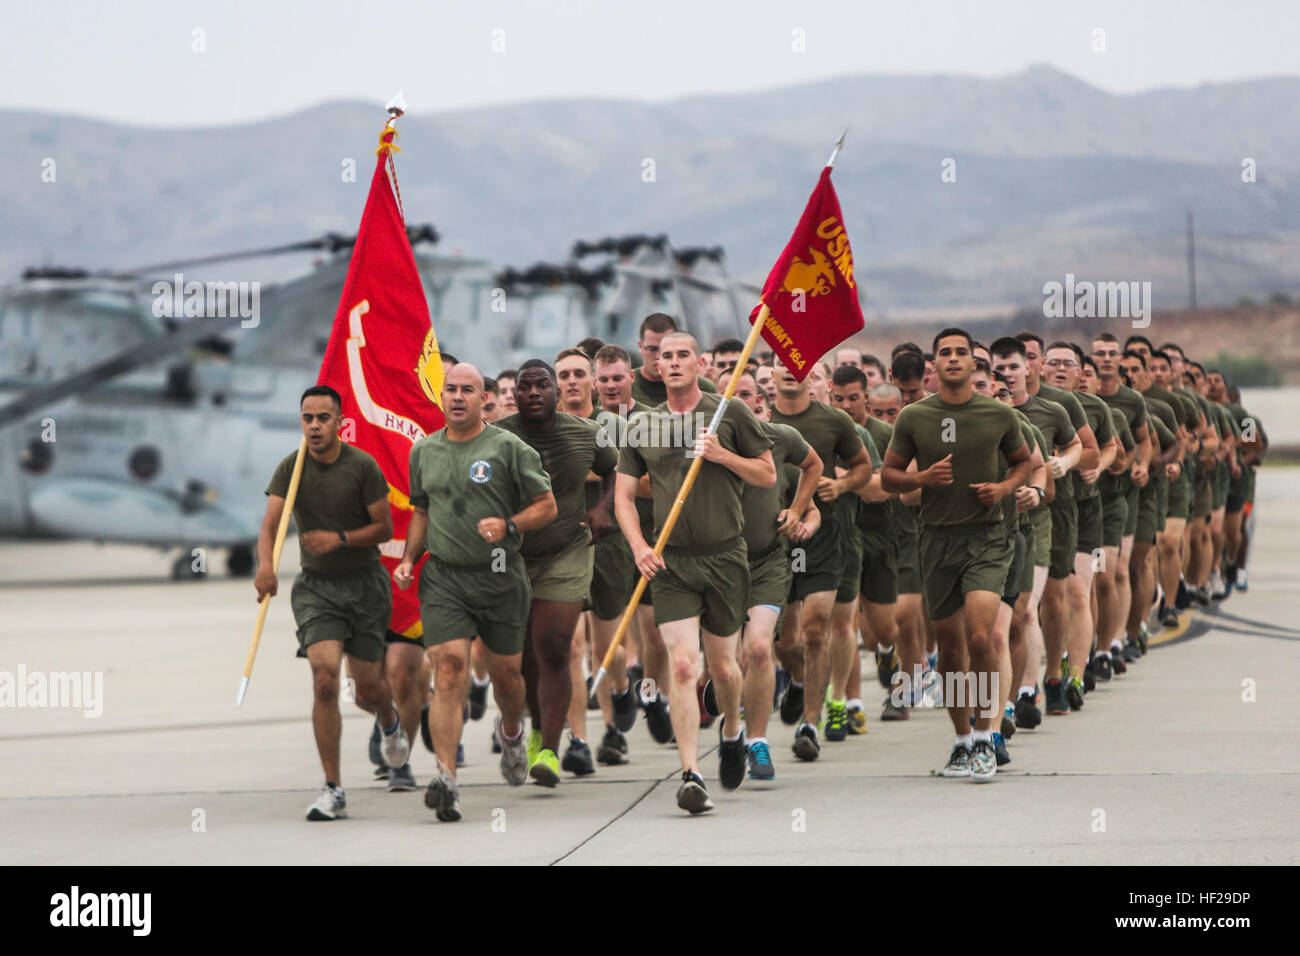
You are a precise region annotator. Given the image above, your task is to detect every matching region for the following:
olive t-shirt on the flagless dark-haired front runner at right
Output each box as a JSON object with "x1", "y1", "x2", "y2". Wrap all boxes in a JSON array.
[{"x1": 889, "y1": 393, "x2": 1024, "y2": 525}]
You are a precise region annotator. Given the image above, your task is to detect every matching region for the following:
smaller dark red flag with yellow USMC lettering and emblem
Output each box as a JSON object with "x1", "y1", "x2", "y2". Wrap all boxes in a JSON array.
[{"x1": 749, "y1": 166, "x2": 865, "y2": 381}]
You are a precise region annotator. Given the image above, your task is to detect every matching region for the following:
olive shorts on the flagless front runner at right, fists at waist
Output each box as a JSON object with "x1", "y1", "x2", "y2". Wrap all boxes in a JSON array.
[{"x1": 917, "y1": 522, "x2": 1013, "y2": 620}]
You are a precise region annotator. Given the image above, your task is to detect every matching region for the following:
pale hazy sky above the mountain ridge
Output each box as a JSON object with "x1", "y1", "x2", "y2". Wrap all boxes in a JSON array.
[{"x1": 0, "y1": 0, "x2": 1300, "y2": 126}]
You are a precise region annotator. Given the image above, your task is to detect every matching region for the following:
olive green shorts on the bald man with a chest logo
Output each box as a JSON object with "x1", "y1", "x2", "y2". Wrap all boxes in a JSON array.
[{"x1": 420, "y1": 554, "x2": 533, "y2": 657}]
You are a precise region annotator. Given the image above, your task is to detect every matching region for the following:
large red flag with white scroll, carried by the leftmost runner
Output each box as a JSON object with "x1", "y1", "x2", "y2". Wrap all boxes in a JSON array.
[{"x1": 319, "y1": 130, "x2": 443, "y2": 637}]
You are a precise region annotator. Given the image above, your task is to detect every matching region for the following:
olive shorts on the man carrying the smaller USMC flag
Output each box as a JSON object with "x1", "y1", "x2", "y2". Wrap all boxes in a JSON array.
[{"x1": 650, "y1": 536, "x2": 749, "y2": 637}]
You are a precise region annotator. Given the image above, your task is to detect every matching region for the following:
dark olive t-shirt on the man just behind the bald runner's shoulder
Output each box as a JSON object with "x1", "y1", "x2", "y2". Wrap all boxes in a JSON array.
[{"x1": 497, "y1": 411, "x2": 619, "y2": 562}]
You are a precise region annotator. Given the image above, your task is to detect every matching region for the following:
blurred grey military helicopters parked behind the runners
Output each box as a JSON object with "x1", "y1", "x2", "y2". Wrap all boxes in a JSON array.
[{"x1": 0, "y1": 225, "x2": 759, "y2": 579}]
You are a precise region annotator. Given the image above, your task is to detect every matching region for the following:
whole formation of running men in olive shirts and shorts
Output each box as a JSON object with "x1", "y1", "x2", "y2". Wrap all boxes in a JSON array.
[{"x1": 256, "y1": 313, "x2": 1268, "y2": 821}]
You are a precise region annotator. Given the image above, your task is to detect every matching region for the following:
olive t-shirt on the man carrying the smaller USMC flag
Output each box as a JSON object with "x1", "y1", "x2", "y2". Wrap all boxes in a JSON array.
[{"x1": 619, "y1": 393, "x2": 772, "y2": 550}]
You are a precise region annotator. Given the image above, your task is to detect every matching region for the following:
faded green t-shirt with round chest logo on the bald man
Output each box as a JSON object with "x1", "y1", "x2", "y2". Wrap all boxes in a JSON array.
[{"x1": 411, "y1": 425, "x2": 551, "y2": 567}]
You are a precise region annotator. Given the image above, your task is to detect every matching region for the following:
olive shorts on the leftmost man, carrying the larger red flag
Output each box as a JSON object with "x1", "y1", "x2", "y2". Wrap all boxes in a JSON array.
[{"x1": 289, "y1": 561, "x2": 393, "y2": 662}]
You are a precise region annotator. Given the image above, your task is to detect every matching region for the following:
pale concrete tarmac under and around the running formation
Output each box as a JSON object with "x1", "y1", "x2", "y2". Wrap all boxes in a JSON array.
[{"x1": 0, "y1": 468, "x2": 1300, "y2": 865}]
